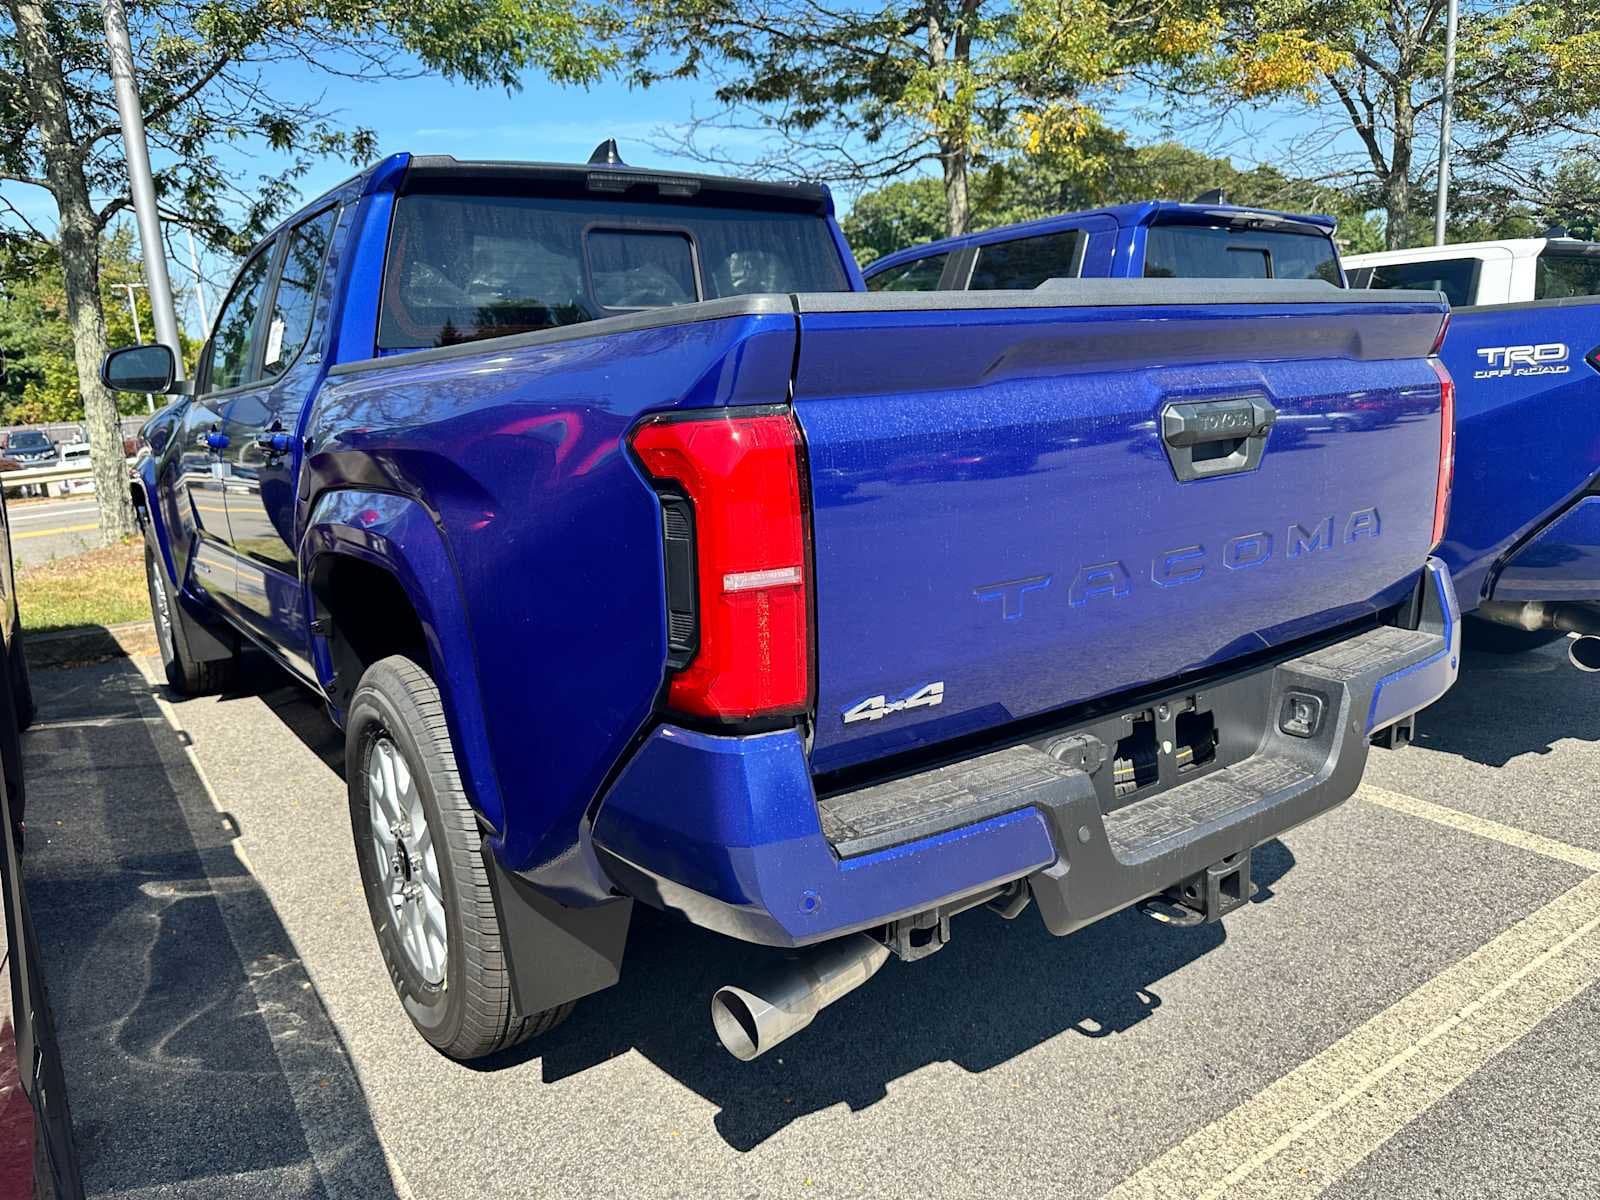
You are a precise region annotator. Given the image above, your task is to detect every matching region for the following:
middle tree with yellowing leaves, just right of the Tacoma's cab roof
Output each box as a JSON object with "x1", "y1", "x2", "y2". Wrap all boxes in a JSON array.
[{"x1": 627, "y1": 0, "x2": 1218, "y2": 234}]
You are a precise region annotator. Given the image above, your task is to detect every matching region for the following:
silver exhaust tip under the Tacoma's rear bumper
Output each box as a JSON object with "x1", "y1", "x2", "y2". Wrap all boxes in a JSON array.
[{"x1": 710, "y1": 933, "x2": 890, "y2": 1062}]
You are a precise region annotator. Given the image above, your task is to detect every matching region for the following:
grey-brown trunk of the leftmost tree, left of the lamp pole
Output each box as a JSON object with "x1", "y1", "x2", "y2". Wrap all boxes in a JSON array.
[{"x1": 10, "y1": 0, "x2": 136, "y2": 541}]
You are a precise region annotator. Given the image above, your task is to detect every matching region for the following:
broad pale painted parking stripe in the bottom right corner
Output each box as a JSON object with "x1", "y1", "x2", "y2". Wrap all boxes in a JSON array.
[{"x1": 1107, "y1": 875, "x2": 1600, "y2": 1200}]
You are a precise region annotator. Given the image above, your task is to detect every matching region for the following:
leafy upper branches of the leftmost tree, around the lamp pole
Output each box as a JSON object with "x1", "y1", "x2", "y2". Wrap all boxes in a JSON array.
[{"x1": 0, "y1": 0, "x2": 616, "y2": 253}]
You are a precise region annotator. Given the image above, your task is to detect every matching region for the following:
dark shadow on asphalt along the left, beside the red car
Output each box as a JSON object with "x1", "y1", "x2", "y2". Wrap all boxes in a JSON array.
[{"x1": 22, "y1": 659, "x2": 395, "y2": 1200}]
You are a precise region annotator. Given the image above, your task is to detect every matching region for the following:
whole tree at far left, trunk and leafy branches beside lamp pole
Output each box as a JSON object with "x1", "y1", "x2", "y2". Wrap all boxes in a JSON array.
[{"x1": 0, "y1": 0, "x2": 614, "y2": 538}]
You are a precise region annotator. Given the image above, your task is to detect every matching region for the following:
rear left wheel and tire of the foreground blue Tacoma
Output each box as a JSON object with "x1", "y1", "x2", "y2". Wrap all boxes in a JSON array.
[{"x1": 344, "y1": 654, "x2": 573, "y2": 1059}]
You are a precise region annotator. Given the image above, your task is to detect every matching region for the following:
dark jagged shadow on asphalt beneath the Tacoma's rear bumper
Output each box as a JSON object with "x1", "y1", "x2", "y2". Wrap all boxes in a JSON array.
[{"x1": 518, "y1": 842, "x2": 1294, "y2": 1150}]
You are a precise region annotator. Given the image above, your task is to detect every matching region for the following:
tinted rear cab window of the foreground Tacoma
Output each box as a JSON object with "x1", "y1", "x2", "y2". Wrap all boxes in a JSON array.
[{"x1": 378, "y1": 194, "x2": 850, "y2": 350}]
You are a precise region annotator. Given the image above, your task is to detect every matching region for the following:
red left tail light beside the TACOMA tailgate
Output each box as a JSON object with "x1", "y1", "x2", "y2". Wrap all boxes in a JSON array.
[{"x1": 632, "y1": 410, "x2": 811, "y2": 720}]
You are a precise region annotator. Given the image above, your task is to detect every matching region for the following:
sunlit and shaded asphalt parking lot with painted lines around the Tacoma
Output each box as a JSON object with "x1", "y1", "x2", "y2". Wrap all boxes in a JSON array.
[{"x1": 24, "y1": 633, "x2": 1600, "y2": 1200}]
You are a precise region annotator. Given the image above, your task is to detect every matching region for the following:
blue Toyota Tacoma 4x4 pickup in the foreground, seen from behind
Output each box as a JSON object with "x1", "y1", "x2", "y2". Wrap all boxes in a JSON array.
[{"x1": 102, "y1": 154, "x2": 1459, "y2": 1058}]
